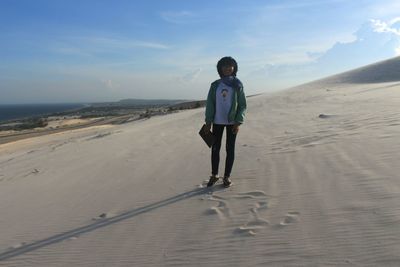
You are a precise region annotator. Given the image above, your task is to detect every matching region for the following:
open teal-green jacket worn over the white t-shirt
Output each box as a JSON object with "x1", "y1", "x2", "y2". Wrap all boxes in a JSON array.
[{"x1": 205, "y1": 80, "x2": 247, "y2": 124}]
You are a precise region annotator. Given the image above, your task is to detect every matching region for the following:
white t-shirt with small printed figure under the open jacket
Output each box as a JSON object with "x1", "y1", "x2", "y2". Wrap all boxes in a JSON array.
[{"x1": 214, "y1": 82, "x2": 234, "y2": 125}]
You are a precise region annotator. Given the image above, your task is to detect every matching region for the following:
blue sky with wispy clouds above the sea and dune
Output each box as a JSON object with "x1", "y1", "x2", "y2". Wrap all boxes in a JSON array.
[{"x1": 0, "y1": 0, "x2": 400, "y2": 104}]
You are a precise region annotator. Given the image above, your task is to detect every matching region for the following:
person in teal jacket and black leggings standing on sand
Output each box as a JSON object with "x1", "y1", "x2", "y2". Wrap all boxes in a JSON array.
[{"x1": 205, "y1": 57, "x2": 247, "y2": 187}]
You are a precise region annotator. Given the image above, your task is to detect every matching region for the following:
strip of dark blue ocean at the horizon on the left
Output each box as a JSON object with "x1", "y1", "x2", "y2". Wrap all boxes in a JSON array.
[{"x1": 0, "y1": 104, "x2": 85, "y2": 122}]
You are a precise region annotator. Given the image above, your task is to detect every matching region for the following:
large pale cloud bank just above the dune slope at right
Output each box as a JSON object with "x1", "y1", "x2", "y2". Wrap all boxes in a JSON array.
[{"x1": 248, "y1": 17, "x2": 400, "y2": 91}]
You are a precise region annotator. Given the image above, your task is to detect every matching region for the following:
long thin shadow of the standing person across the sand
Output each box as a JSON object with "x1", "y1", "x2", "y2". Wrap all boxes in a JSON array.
[{"x1": 0, "y1": 186, "x2": 222, "y2": 261}]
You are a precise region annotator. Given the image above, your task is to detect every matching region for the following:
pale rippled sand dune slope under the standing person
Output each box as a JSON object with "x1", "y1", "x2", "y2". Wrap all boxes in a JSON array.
[{"x1": 0, "y1": 58, "x2": 400, "y2": 266}]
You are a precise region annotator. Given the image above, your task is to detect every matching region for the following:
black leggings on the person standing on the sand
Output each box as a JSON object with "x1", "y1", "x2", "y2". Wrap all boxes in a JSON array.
[{"x1": 211, "y1": 124, "x2": 236, "y2": 177}]
